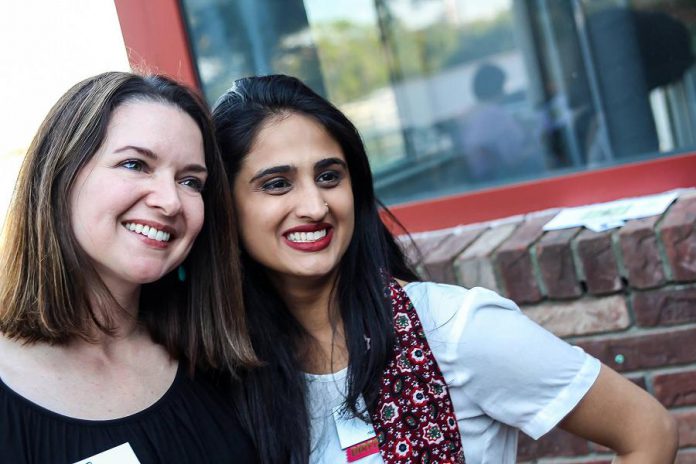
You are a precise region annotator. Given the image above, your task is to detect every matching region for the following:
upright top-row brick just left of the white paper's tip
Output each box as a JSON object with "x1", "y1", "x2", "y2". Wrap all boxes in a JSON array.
[{"x1": 495, "y1": 214, "x2": 553, "y2": 303}]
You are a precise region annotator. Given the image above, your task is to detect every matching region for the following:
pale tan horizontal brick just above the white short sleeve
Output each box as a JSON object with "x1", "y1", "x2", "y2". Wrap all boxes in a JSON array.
[{"x1": 523, "y1": 295, "x2": 631, "y2": 337}]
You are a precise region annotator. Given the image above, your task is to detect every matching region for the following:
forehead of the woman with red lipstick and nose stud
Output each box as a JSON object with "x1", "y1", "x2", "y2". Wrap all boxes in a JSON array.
[{"x1": 244, "y1": 113, "x2": 345, "y2": 168}]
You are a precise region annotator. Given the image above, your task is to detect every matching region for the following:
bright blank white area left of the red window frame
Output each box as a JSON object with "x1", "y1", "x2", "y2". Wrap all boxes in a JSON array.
[{"x1": 0, "y1": 0, "x2": 130, "y2": 223}]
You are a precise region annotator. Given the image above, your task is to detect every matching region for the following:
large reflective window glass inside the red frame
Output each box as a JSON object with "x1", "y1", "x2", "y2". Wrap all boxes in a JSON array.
[{"x1": 182, "y1": 0, "x2": 696, "y2": 204}]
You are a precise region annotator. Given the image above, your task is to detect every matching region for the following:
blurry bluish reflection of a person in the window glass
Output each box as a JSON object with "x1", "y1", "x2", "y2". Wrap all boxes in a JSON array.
[{"x1": 460, "y1": 63, "x2": 542, "y2": 180}]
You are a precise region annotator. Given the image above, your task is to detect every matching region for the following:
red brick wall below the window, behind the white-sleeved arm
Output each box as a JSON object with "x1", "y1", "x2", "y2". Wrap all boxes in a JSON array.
[{"x1": 402, "y1": 190, "x2": 696, "y2": 464}]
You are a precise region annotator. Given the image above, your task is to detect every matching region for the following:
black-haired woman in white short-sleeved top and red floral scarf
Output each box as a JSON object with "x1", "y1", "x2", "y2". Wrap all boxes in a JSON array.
[{"x1": 213, "y1": 75, "x2": 676, "y2": 463}]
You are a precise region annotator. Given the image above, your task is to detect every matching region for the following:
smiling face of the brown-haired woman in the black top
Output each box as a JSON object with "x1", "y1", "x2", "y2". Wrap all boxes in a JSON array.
[{"x1": 70, "y1": 101, "x2": 206, "y2": 291}]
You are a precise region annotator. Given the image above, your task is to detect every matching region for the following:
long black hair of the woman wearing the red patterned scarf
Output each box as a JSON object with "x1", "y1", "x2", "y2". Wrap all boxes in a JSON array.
[{"x1": 213, "y1": 75, "x2": 417, "y2": 463}]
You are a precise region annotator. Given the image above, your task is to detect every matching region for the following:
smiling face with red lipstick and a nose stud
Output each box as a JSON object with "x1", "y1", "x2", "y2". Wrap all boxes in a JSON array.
[{"x1": 233, "y1": 113, "x2": 354, "y2": 281}]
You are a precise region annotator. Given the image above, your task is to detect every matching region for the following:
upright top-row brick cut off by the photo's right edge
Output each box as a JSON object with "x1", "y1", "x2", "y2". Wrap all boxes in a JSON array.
[{"x1": 660, "y1": 197, "x2": 696, "y2": 282}]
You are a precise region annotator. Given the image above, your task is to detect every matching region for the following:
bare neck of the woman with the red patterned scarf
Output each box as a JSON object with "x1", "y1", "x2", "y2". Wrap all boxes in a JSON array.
[{"x1": 271, "y1": 273, "x2": 348, "y2": 374}]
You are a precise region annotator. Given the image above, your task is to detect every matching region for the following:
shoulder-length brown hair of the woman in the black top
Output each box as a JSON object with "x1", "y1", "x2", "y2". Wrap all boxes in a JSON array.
[{"x1": 0, "y1": 72, "x2": 256, "y2": 373}]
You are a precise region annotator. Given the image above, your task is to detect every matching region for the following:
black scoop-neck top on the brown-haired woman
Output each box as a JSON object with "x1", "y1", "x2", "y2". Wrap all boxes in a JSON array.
[{"x1": 0, "y1": 364, "x2": 256, "y2": 464}]
